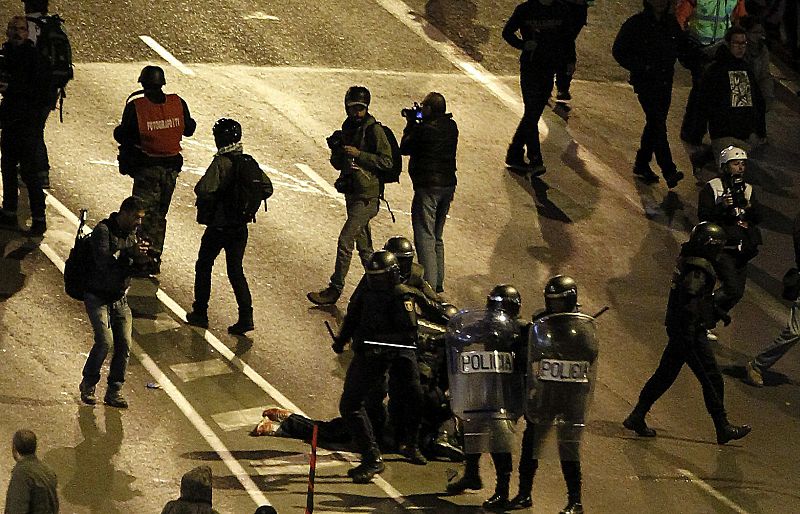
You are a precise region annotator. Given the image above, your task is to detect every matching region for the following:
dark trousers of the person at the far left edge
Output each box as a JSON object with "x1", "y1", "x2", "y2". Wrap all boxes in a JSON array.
[{"x1": 0, "y1": 124, "x2": 50, "y2": 221}]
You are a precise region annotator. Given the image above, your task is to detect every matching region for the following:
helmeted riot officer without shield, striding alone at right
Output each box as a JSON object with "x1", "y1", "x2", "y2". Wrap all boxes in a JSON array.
[{"x1": 623, "y1": 221, "x2": 750, "y2": 444}]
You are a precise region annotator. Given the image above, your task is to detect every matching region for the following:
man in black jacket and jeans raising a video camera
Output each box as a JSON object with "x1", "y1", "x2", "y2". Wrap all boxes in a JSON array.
[{"x1": 400, "y1": 92, "x2": 458, "y2": 293}]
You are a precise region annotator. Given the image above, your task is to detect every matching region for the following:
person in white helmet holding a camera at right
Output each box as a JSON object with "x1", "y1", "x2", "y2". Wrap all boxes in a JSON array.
[{"x1": 697, "y1": 146, "x2": 762, "y2": 326}]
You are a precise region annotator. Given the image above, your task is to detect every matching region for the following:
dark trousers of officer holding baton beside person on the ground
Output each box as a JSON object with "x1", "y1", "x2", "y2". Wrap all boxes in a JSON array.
[{"x1": 339, "y1": 349, "x2": 422, "y2": 454}]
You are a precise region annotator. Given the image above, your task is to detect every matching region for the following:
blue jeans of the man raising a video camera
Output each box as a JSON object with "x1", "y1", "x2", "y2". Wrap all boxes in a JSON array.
[{"x1": 411, "y1": 186, "x2": 456, "y2": 293}]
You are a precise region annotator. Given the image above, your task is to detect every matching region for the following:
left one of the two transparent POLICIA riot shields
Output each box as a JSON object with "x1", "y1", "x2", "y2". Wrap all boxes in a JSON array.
[{"x1": 446, "y1": 310, "x2": 526, "y2": 453}]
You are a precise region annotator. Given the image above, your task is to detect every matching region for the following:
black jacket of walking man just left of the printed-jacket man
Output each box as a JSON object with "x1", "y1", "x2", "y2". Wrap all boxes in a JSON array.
[{"x1": 612, "y1": 2, "x2": 688, "y2": 90}]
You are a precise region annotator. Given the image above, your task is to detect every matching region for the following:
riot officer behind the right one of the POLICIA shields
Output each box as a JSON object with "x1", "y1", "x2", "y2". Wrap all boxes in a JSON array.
[{"x1": 507, "y1": 275, "x2": 597, "y2": 514}]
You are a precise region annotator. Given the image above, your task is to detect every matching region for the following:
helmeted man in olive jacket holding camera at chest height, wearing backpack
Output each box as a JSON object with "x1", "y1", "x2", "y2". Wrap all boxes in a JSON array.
[{"x1": 306, "y1": 86, "x2": 393, "y2": 305}]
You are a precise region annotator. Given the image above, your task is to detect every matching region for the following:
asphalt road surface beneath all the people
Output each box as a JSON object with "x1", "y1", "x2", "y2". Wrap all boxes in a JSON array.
[{"x1": 0, "y1": 0, "x2": 800, "y2": 514}]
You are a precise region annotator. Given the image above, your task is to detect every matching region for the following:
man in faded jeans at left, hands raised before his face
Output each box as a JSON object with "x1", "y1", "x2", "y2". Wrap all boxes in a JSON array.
[{"x1": 78, "y1": 196, "x2": 149, "y2": 409}]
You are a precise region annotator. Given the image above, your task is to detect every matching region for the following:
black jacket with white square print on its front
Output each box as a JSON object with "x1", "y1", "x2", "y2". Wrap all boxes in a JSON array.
[{"x1": 689, "y1": 45, "x2": 767, "y2": 144}]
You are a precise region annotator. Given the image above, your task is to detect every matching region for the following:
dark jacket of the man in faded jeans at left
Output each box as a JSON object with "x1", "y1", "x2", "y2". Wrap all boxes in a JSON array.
[{"x1": 87, "y1": 212, "x2": 136, "y2": 302}]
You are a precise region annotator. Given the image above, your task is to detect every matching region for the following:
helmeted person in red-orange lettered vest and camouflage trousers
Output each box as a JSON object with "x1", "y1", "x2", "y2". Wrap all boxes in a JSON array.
[{"x1": 114, "y1": 66, "x2": 197, "y2": 275}]
